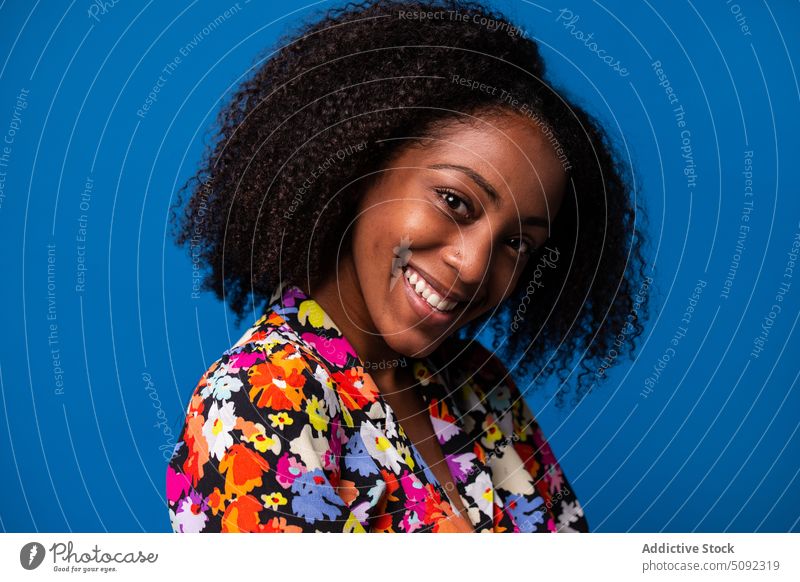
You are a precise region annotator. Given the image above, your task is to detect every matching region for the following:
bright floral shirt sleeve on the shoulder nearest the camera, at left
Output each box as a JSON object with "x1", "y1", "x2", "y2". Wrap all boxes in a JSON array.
[{"x1": 166, "y1": 331, "x2": 364, "y2": 533}]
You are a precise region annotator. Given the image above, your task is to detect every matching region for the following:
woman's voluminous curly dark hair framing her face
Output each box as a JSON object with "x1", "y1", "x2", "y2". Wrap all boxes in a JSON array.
[{"x1": 172, "y1": 0, "x2": 647, "y2": 405}]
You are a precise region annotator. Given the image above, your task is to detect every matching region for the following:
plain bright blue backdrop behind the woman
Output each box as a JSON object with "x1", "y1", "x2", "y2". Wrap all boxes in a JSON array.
[{"x1": 0, "y1": 0, "x2": 800, "y2": 532}]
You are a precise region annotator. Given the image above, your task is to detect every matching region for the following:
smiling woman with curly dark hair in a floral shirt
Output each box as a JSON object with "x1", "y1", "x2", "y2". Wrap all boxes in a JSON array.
[{"x1": 167, "y1": 1, "x2": 642, "y2": 532}]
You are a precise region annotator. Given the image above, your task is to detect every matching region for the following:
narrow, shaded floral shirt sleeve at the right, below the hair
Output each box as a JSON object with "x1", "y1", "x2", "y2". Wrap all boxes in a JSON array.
[{"x1": 468, "y1": 342, "x2": 589, "y2": 532}]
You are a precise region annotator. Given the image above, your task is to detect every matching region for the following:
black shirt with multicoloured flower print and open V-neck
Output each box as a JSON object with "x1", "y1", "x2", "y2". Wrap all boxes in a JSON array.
[{"x1": 166, "y1": 285, "x2": 588, "y2": 532}]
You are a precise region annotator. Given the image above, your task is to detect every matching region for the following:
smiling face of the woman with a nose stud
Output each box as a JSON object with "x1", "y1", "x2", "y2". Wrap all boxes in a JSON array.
[{"x1": 339, "y1": 114, "x2": 566, "y2": 357}]
